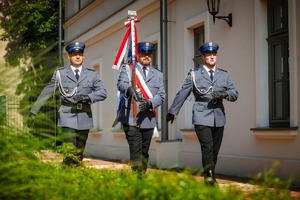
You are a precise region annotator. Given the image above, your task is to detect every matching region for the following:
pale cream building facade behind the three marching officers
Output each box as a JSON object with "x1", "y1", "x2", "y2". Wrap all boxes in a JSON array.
[{"x1": 63, "y1": 0, "x2": 300, "y2": 177}]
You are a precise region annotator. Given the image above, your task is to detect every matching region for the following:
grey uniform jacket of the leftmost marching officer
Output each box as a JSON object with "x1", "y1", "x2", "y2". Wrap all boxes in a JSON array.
[{"x1": 30, "y1": 67, "x2": 107, "y2": 130}]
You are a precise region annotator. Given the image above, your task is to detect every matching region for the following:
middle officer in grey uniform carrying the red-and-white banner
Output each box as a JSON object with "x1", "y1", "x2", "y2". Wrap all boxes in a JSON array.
[{"x1": 117, "y1": 42, "x2": 165, "y2": 174}]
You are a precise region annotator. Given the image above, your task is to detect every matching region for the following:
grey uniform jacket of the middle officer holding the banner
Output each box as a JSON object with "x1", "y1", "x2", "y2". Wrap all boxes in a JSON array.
[{"x1": 117, "y1": 63, "x2": 166, "y2": 128}]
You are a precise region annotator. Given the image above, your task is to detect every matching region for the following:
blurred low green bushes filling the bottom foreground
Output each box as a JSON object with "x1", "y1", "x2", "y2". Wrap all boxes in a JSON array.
[{"x1": 0, "y1": 130, "x2": 291, "y2": 200}]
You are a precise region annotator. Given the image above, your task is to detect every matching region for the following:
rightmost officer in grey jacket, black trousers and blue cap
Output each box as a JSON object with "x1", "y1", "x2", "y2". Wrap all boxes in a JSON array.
[{"x1": 166, "y1": 42, "x2": 238, "y2": 185}]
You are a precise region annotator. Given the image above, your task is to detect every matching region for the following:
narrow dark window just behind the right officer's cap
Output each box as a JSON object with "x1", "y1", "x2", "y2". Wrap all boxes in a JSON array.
[{"x1": 193, "y1": 26, "x2": 205, "y2": 67}]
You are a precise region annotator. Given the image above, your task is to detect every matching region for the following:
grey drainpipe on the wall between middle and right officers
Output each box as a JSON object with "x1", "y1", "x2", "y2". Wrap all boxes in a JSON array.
[{"x1": 160, "y1": 0, "x2": 169, "y2": 141}]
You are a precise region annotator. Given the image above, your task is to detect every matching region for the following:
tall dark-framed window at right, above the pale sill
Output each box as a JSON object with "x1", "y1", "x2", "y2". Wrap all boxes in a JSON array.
[{"x1": 267, "y1": 0, "x2": 290, "y2": 127}]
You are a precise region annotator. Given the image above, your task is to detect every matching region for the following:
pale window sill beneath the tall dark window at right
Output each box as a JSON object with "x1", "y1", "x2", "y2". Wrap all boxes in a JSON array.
[{"x1": 250, "y1": 127, "x2": 298, "y2": 139}]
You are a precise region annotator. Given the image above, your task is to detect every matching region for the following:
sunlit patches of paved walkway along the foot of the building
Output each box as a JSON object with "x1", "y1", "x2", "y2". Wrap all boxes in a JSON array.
[{"x1": 38, "y1": 151, "x2": 300, "y2": 199}]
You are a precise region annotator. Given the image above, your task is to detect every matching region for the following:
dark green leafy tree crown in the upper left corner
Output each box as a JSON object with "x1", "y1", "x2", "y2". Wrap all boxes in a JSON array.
[{"x1": 0, "y1": 0, "x2": 59, "y2": 66}]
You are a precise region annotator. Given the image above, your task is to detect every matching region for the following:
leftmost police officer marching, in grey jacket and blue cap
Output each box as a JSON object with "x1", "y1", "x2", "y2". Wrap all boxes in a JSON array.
[{"x1": 30, "y1": 42, "x2": 107, "y2": 165}]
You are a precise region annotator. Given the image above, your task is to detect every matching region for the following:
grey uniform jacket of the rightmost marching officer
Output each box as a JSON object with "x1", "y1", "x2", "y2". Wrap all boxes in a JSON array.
[{"x1": 168, "y1": 66, "x2": 238, "y2": 127}]
